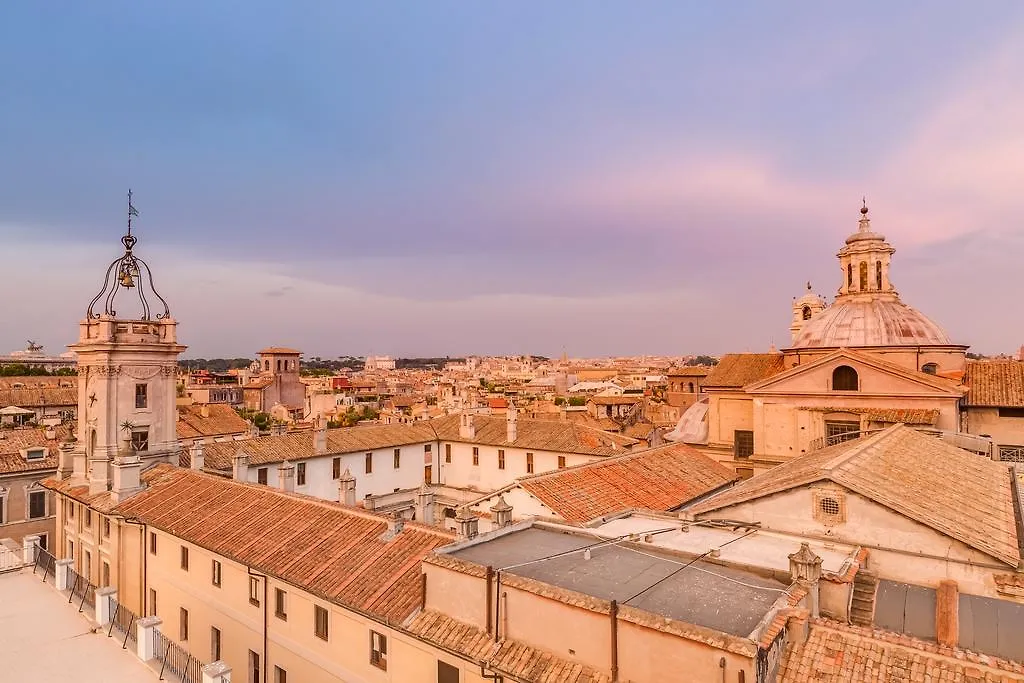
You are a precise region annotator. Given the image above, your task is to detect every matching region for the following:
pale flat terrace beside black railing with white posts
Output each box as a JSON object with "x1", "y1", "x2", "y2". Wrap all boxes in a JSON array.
[{"x1": 0, "y1": 567, "x2": 160, "y2": 683}]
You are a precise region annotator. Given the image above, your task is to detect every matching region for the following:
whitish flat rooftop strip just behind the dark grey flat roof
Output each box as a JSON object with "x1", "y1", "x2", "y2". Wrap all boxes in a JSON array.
[{"x1": 591, "y1": 515, "x2": 857, "y2": 573}]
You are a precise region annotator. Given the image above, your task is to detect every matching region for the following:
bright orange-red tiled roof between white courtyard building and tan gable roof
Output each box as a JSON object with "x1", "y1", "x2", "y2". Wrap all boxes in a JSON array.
[{"x1": 519, "y1": 443, "x2": 738, "y2": 523}]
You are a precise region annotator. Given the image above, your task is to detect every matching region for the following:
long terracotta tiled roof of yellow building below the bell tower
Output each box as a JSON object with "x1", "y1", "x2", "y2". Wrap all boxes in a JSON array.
[{"x1": 47, "y1": 464, "x2": 455, "y2": 624}]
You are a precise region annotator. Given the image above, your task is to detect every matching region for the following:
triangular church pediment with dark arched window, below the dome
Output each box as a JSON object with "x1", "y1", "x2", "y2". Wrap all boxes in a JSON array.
[{"x1": 744, "y1": 349, "x2": 964, "y2": 398}]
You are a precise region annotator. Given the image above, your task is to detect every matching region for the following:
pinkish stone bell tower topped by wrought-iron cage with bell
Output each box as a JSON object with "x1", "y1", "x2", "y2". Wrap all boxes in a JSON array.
[{"x1": 69, "y1": 190, "x2": 186, "y2": 496}]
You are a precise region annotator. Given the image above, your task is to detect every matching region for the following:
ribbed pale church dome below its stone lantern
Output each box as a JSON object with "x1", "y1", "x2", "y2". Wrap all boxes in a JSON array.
[{"x1": 793, "y1": 297, "x2": 952, "y2": 348}]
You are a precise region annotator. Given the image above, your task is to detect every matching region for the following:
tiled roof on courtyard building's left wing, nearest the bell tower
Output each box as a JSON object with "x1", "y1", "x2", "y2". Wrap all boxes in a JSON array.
[{"x1": 197, "y1": 421, "x2": 437, "y2": 470}]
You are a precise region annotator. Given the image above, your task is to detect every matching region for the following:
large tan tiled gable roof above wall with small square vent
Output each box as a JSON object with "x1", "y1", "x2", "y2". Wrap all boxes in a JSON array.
[{"x1": 692, "y1": 425, "x2": 1020, "y2": 566}]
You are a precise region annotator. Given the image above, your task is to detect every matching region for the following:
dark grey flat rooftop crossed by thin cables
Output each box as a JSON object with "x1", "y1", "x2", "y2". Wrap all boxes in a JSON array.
[{"x1": 451, "y1": 524, "x2": 788, "y2": 638}]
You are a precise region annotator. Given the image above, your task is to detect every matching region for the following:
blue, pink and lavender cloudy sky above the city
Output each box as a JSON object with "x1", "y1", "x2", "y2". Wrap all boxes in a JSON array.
[{"x1": 0, "y1": 0, "x2": 1024, "y2": 357}]
